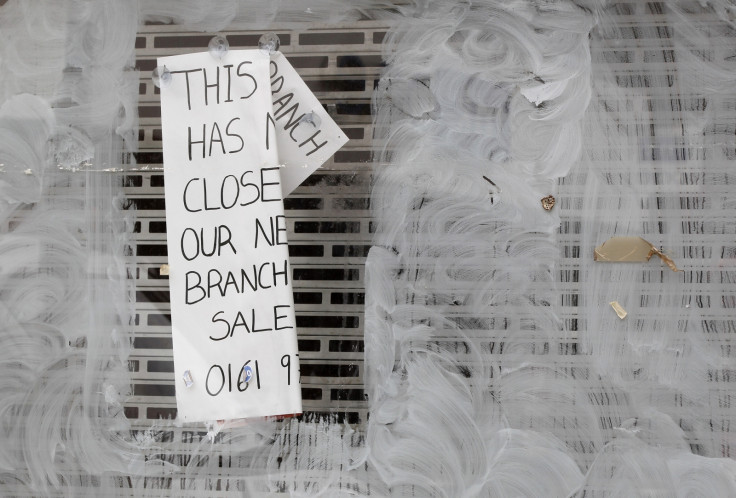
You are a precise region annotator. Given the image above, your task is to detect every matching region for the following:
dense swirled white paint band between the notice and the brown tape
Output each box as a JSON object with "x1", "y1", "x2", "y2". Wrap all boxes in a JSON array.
[{"x1": 366, "y1": 2, "x2": 601, "y2": 496}]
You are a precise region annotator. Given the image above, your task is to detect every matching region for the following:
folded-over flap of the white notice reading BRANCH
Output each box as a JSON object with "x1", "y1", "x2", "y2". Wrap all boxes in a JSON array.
[{"x1": 270, "y1": 52, "x2": 348, "y2": 196}]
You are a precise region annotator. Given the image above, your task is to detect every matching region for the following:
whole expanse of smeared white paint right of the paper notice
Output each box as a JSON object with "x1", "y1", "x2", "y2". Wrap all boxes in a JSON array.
[{"x1": 366, "y1": 2, "x2": 736, "y2": 496}]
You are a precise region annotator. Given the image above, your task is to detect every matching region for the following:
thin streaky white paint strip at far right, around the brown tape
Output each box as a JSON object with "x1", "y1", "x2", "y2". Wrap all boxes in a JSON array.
[{"x1": 563, "y1": 4, "x2": 736, "y2": 496}]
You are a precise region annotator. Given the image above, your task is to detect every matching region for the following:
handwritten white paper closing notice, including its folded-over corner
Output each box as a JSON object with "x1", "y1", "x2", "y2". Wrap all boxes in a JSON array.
[{"x1": 158, "y1": 49, "x2": 347, "y2": 422}]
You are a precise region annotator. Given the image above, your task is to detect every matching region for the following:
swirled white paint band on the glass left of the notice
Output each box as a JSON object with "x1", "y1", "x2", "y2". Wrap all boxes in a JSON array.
[{"x1": 0, "y1": 2, "x2": 143, "y2": 496}]
